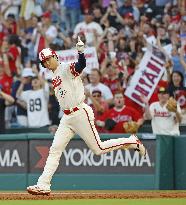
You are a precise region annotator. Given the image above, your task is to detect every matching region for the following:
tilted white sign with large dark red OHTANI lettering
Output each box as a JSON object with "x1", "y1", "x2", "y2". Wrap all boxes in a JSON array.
[{"x1": 125, "y1": 44, "x2": 166, "y2": 107}]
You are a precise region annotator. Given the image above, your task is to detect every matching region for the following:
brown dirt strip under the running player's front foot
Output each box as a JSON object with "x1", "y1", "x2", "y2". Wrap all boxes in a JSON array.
[{"x1": 0, "y1": 191, "x2": 186, "y2": 200}]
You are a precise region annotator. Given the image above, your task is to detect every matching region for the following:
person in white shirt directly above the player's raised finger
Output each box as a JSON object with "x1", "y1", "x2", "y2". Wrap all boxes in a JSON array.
[{"x1": 74, "y1": 10, "x2": 103, "y2": 46}]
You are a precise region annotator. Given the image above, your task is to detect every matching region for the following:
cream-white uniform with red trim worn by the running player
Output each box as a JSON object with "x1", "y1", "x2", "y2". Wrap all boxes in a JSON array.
[{"x1": 37, "y1": 63, "x2": 136, "y2": 189}]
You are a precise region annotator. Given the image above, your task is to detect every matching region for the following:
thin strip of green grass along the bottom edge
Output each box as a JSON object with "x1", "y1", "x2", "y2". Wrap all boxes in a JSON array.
[{"x1": 0, "y1": 198, "x2": 186, "y2": 205}]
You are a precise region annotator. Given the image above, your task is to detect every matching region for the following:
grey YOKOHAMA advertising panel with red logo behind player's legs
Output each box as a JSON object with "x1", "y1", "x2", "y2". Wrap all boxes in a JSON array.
[{"x1": 29, "y1": 139, "x2": 156, "y2": 174}]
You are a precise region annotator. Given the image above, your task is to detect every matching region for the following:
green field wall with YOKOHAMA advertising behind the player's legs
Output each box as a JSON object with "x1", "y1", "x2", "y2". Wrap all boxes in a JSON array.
[{"x1": 0, "y1": 133, "x2": 186, "y2": 190}]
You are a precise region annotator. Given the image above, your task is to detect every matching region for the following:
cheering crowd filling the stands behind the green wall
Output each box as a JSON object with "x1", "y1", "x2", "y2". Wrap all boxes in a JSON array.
[{"x1": 0, "y1": 0, "x2": 186, "y2": 135}]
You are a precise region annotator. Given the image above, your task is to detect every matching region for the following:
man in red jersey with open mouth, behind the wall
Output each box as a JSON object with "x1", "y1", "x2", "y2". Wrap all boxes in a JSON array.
[{"x1": 96, "y1": 92, "x2": 143, "y2": 133}]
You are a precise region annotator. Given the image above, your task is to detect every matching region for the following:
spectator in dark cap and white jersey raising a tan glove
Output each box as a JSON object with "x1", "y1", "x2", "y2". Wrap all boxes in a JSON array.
[{"x1": 144, "y1": 87, "x2": 181, "y2": 135}]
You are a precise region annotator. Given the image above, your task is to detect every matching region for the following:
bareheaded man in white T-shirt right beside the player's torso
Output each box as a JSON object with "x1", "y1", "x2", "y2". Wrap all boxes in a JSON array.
[{"x1": 85, "y1": 68, "x2": 113, "y2": 104}]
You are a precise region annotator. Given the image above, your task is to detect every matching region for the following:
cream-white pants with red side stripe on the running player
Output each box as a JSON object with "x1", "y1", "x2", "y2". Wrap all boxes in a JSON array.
[{"x1": 37, "y1": 103, "x2": 136, "y2": 189}]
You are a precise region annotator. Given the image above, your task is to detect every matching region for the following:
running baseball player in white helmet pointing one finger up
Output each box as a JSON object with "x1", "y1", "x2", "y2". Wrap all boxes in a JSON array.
[{"x1": 27, "y1": 37, "x2": 146, "y2": 195}]
